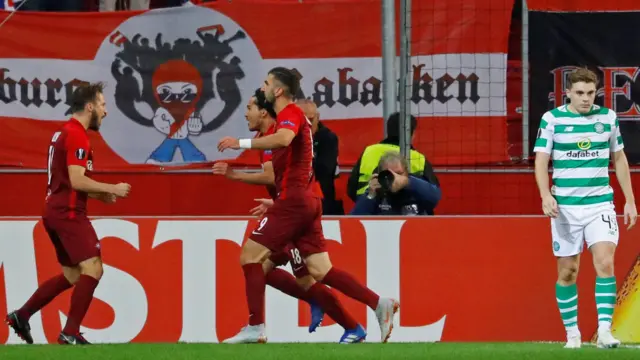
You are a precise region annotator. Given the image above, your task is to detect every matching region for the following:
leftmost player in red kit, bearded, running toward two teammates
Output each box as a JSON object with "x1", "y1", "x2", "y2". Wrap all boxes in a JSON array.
[{"x1": 6, "y1": 83, "x2": 131, "y2": 345}]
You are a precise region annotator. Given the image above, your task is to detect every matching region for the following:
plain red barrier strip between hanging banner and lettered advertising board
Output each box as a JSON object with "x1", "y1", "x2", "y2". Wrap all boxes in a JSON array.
[{"x1": 0, "y1": 172, "x2": 640, "y2": 217}]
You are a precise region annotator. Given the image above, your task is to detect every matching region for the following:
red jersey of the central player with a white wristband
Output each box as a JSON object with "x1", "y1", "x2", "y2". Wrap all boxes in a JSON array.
[{"x1": 271, "y1": 104, "x2": 319, "y2": 199}]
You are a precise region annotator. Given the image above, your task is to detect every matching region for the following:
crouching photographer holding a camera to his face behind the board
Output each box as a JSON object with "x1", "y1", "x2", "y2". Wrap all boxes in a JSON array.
[{"x1": 351, "y1": 151, "x2": 442, "y2": 215}]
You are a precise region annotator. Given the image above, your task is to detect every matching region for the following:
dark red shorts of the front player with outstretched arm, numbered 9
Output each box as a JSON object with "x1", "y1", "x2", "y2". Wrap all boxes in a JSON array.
[{"x1": 249, "y1": 196, "x2": 326, "y2": 258}]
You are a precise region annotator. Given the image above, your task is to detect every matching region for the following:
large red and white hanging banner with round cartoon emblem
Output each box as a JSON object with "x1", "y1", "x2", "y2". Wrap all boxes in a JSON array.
[{"x1": 0, "y1": 0, "x2": 512, "y2": 171}]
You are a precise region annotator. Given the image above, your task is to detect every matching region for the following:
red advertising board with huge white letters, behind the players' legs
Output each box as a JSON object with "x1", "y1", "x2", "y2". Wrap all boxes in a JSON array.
[{"x1": 0, "y1": 217, "x2": 640, "y2": 343}]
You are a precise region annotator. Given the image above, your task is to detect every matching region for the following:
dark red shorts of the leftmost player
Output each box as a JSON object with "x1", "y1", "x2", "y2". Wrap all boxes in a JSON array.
[{"x1": 42, "y1": 217, "x2": 100, "y2": 267}]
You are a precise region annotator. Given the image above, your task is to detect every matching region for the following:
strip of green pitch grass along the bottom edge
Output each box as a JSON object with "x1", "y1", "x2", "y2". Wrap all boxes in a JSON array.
[{"x1": 0, "y1": 343, "x2": 640, "y2": 360}]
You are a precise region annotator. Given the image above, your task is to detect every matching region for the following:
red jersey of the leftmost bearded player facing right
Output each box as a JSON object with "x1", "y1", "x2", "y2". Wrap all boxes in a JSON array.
[{"x1": 45, "y1": 119, "x2": 93, "y2": 218}]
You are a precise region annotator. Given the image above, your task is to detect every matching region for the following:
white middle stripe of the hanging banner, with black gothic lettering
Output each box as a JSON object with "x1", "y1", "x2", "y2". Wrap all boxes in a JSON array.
[{"x1": 0, "y1": 53, "x2": 506, "y2": 120}]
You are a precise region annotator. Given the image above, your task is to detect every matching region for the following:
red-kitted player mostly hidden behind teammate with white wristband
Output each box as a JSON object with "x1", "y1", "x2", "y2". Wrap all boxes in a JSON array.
[{"x1": 213, "y1": 89, "x2": 358, "y2": 344}]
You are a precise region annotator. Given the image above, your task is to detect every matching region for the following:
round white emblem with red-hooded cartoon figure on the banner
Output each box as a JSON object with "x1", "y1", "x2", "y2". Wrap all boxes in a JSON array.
[{"x1": 95, "y1": 6, "x2": 265, "y2": 165}]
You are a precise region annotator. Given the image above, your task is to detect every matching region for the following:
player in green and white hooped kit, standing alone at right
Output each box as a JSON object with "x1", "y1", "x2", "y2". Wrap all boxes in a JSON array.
[{"x1": 534, "y1": 69, "x2": 638, "y2": 348}]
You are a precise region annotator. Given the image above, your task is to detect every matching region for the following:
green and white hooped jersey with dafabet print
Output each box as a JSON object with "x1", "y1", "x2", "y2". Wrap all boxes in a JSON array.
[{"x1": 533, "y1": 105, "x2": 624, "y2": 206}]
